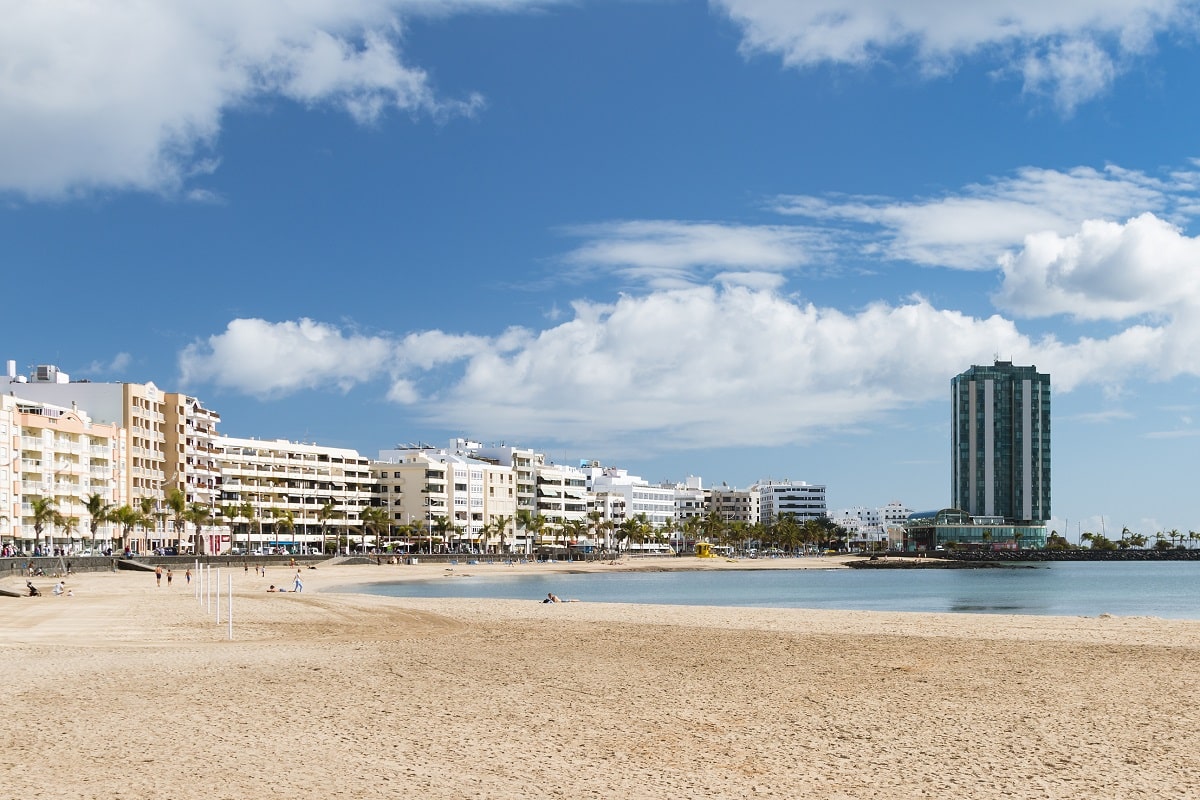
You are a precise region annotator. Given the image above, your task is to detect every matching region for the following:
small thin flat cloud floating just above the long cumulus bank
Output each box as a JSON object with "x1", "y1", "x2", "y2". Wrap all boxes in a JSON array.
[{"x1": 564, "y1": 219, "x2": 827, "y2": 289}]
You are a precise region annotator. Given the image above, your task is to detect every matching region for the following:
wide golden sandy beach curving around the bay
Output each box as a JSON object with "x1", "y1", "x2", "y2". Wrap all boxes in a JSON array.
[{"x1": 0, "y1": 559, "x2": 1200, "y2": 800}]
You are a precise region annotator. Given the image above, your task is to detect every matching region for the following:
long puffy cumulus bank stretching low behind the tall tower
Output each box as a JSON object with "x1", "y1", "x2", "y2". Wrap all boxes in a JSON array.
[{"x1": 180, "y1": 285, "x2": 1200, "y2": 453}]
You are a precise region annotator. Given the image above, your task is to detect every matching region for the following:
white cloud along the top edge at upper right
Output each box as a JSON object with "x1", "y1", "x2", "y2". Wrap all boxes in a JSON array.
[{"x1": 710, "y1": 0, "x2": 1194, "y2": 110}]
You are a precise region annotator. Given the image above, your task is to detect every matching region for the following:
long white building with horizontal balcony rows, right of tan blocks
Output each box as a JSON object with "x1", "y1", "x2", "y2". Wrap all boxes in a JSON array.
[{"x1": 209, "y1": 437, "x2": 373, "y2": 553}]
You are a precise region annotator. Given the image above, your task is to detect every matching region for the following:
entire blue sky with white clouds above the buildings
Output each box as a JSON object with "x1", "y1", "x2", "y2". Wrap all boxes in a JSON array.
[{"x1": 0, "y1": 0, "x2": 1200, "y2": 539}]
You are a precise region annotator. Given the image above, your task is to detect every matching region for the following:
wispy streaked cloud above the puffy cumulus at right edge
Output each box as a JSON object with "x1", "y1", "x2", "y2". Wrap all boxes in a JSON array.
[{"x1": 774, "y1": 166, "x2": 1180, "y2": 270}]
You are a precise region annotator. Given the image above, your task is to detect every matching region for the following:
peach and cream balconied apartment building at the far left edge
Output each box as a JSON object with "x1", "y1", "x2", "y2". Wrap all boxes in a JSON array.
[{"x1": 0, "y1": 395, "x2": 126, "y2": 554}]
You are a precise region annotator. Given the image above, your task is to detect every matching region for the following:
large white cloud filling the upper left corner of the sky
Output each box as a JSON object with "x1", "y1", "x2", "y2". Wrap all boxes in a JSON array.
[{"x1": 0, "y1": 0, "x2": 544, "y2": 198}]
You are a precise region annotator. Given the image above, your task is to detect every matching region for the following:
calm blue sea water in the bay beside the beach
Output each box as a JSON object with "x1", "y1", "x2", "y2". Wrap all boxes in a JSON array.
[{"x1": 355, "y1": 561, "x2": 1200, "y2": 619}]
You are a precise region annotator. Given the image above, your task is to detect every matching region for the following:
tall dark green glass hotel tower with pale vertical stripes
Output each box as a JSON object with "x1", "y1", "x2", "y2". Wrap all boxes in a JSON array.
[{"x1": 950, "y1": 361, "x2": 1050, "y2": 524}]
